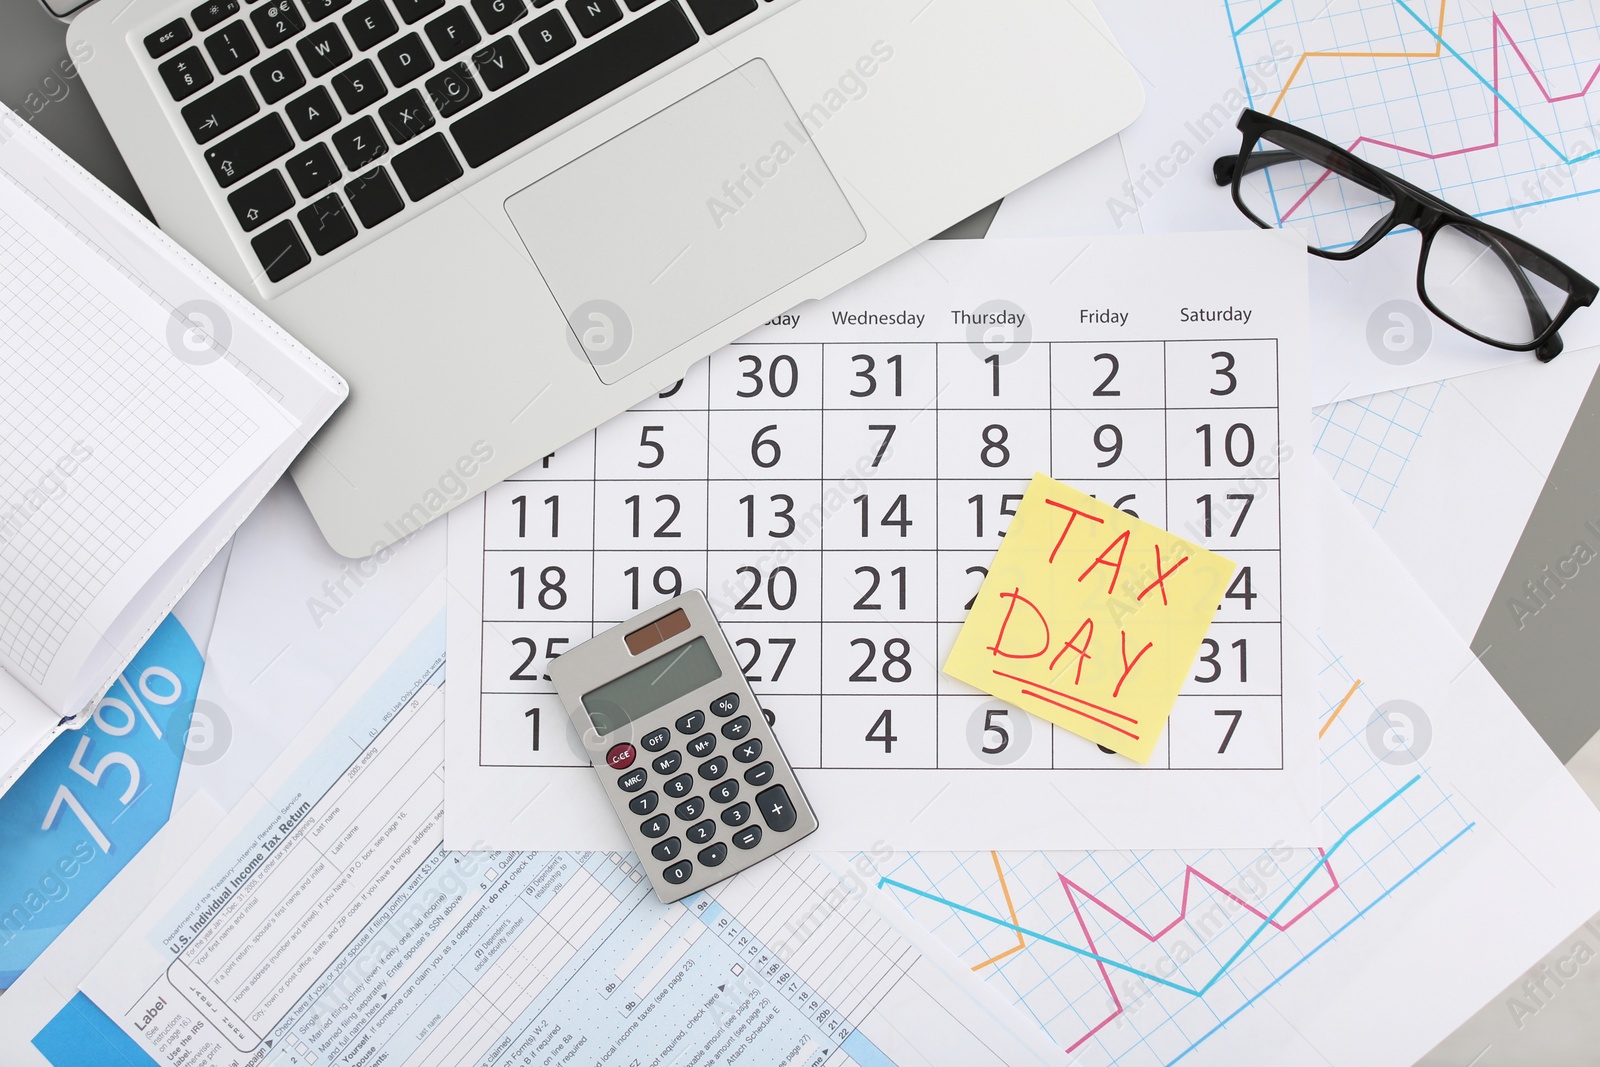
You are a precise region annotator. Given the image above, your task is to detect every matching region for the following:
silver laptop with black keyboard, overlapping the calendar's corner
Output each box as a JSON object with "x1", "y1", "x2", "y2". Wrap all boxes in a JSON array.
[{"x1": 53, "y1": 0, "x2": 1142, "y2": 557}]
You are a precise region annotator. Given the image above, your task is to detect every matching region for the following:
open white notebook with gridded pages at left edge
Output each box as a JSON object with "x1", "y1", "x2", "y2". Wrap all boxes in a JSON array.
[{"x1": 0, "y1": 107, "x2": 347, "y2": 792}]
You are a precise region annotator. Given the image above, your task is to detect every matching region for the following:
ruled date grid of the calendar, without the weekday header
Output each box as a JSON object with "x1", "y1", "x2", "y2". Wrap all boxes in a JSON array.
[{"x1": 480, "y1": 338, "x2": 1285, "y2": 773}]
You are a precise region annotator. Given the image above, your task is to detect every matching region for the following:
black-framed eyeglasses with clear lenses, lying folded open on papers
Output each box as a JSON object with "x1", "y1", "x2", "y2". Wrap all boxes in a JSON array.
[{"x1": 1211, "y1": 109, "x2": 1600, "y2": 362}]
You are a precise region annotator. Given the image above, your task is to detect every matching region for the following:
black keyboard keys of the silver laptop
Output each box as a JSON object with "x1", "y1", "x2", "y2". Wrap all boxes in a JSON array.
[{"x1": 144, "y1": 0, "x2": 760, "y2": 283}]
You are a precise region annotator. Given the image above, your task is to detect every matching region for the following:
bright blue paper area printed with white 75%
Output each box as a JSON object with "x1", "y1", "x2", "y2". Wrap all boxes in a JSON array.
[{"x1": 0, "y1": 616, "x2": 205, "y2": 990}]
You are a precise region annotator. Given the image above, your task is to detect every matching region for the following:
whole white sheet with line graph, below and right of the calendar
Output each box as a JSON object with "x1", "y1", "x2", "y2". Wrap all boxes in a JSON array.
[{"x1": 877, "y1": 480, "x2": 1600, "y2": 1067}]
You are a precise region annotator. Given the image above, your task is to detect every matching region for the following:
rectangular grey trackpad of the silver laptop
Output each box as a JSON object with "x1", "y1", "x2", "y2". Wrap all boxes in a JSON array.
[{"x1": 506, "y1": 59, "x2": 866, "y2": 384}]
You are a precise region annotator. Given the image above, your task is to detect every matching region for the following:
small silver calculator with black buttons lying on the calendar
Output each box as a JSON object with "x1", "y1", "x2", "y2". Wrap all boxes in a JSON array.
[{"x1": 549, "y1": 590, "x2": 816, "y2": 904}]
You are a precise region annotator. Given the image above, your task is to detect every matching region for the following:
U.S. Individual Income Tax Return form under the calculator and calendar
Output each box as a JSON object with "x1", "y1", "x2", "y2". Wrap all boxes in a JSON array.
[{"x1": 68, "y1": 585, "x2": 1050, "y2": 1067}]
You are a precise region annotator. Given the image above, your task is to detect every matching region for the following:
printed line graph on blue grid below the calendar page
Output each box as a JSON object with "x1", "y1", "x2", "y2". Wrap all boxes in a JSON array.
[{"x1": 878, "y1": 646, "x2": 1475, "y2": 1064}]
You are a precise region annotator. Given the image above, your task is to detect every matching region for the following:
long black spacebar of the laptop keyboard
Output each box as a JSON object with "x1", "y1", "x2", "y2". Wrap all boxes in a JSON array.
[{"x1": 450, "y1": 0, "x2": 699, "y2": 166}]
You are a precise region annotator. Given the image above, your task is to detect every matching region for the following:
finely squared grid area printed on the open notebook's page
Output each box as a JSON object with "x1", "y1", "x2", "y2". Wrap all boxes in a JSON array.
[{"x1": 0, "y1": 211, "x2": 256, "y2": 683}]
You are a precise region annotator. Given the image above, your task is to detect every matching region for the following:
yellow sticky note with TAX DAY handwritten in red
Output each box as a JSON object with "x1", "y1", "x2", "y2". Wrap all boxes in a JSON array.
[{"x1": 944, "y1": 474, "x2": 1235, "y2": 763}]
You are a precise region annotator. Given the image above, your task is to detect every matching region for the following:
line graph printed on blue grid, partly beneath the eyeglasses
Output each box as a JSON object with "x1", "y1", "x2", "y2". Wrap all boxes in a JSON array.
[{"x1": 1224, "y1": 0, "x2": 1600, "y2": 226}]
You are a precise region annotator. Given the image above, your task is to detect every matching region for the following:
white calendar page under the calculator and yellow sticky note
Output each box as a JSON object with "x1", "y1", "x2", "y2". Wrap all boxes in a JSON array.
[{"x1": 445, "y1": 232, "x2": 1326, "y2": 849}]
